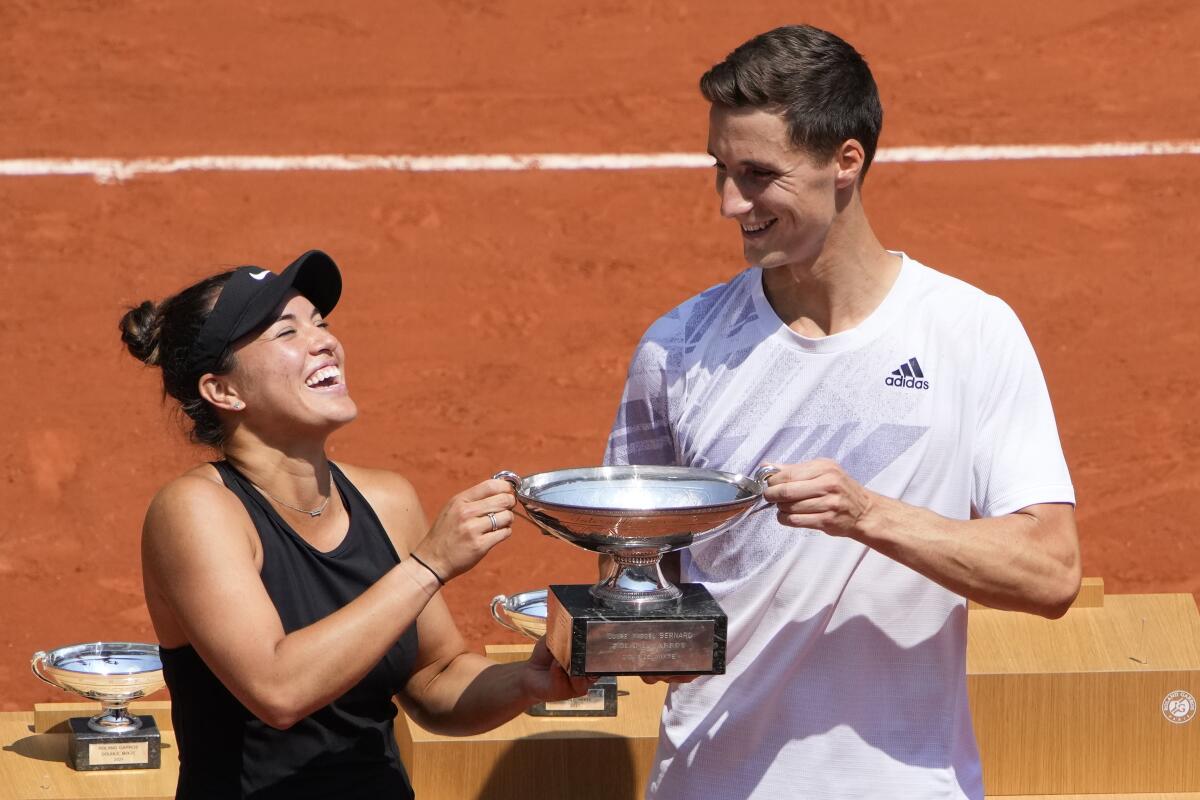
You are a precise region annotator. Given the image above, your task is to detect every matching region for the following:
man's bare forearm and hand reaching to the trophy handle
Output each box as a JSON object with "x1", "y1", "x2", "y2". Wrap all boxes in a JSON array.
[{"x1": 764, "y1": 459, "x2": 1080, "y2": 619}]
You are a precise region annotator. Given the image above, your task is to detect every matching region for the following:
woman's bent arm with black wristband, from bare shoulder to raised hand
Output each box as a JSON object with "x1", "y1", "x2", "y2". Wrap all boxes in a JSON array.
[{"x1": 143, "y1": 475, "x2": 506, "y2": 728}]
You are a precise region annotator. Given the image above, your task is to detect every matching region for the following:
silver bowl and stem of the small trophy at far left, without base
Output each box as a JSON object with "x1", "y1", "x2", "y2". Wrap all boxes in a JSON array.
[{"x1": 30, "y1": 642, "x2": 166, "y2": 733}]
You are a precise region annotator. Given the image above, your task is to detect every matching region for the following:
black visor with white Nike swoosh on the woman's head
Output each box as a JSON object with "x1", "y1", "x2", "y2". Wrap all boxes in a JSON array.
[{"x1": 187, "y1": 249, "x2": 342, "y2": 374}]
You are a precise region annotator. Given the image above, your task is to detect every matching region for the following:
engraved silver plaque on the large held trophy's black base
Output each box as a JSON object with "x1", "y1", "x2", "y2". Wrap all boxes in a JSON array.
[{"x1": 586, "y1": 620, "x2": 714, "y2": 674}]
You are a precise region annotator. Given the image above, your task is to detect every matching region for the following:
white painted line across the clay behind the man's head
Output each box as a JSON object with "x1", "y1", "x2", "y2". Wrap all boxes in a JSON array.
[{"x1": 0, "y1": 139, "x2": 1200, "y2": 184}]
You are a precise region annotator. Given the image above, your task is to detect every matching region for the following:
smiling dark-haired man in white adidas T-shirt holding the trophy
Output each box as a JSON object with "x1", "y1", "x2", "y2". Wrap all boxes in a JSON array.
[{"x1": 607, "y1": 26, "x2": 1080, "y2": 800}]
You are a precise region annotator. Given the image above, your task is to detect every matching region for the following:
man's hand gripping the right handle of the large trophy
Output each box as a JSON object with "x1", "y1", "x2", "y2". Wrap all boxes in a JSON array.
[{"x1": 763, "y1": 458, "x2": 881, "y2": 539}]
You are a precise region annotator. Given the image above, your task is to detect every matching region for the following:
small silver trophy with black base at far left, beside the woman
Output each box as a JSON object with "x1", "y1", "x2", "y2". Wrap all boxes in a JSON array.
[{"x1": 30, "y1": 642, "x2": 166, "y2": 770}]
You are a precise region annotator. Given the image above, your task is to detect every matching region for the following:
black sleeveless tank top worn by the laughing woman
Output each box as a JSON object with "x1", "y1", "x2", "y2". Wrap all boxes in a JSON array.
[{"x1": 161, "y1": 462, "x2": 416, "y2": 800}]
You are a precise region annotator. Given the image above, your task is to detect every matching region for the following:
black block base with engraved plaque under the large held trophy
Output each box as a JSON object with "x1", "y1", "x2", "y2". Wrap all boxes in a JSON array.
[{"x1": 546, "y1": 583, "x2": 727, "y2": 675}]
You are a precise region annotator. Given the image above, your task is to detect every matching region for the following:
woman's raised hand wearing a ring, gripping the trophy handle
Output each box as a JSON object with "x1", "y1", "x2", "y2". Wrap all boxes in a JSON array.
[{"x1": 413, "y1": 479, "x2": 516, "y2": 581}]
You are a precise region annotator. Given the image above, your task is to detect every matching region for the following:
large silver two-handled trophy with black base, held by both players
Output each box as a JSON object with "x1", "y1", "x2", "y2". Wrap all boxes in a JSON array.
[{"x1": 496, "y1": 465, "x2": 776, "y2": 675}]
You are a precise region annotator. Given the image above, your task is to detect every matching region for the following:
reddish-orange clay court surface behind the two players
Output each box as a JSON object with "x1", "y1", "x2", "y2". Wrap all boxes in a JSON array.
[{"x1": 0, "y1": 0, "x2": 1200, "y2": 709}]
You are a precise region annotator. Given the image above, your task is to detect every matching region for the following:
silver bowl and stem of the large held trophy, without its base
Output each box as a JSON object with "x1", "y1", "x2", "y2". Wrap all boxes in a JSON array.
[{"x1": 494, "y1": 464, "x2": 778, "y2": 608}]
